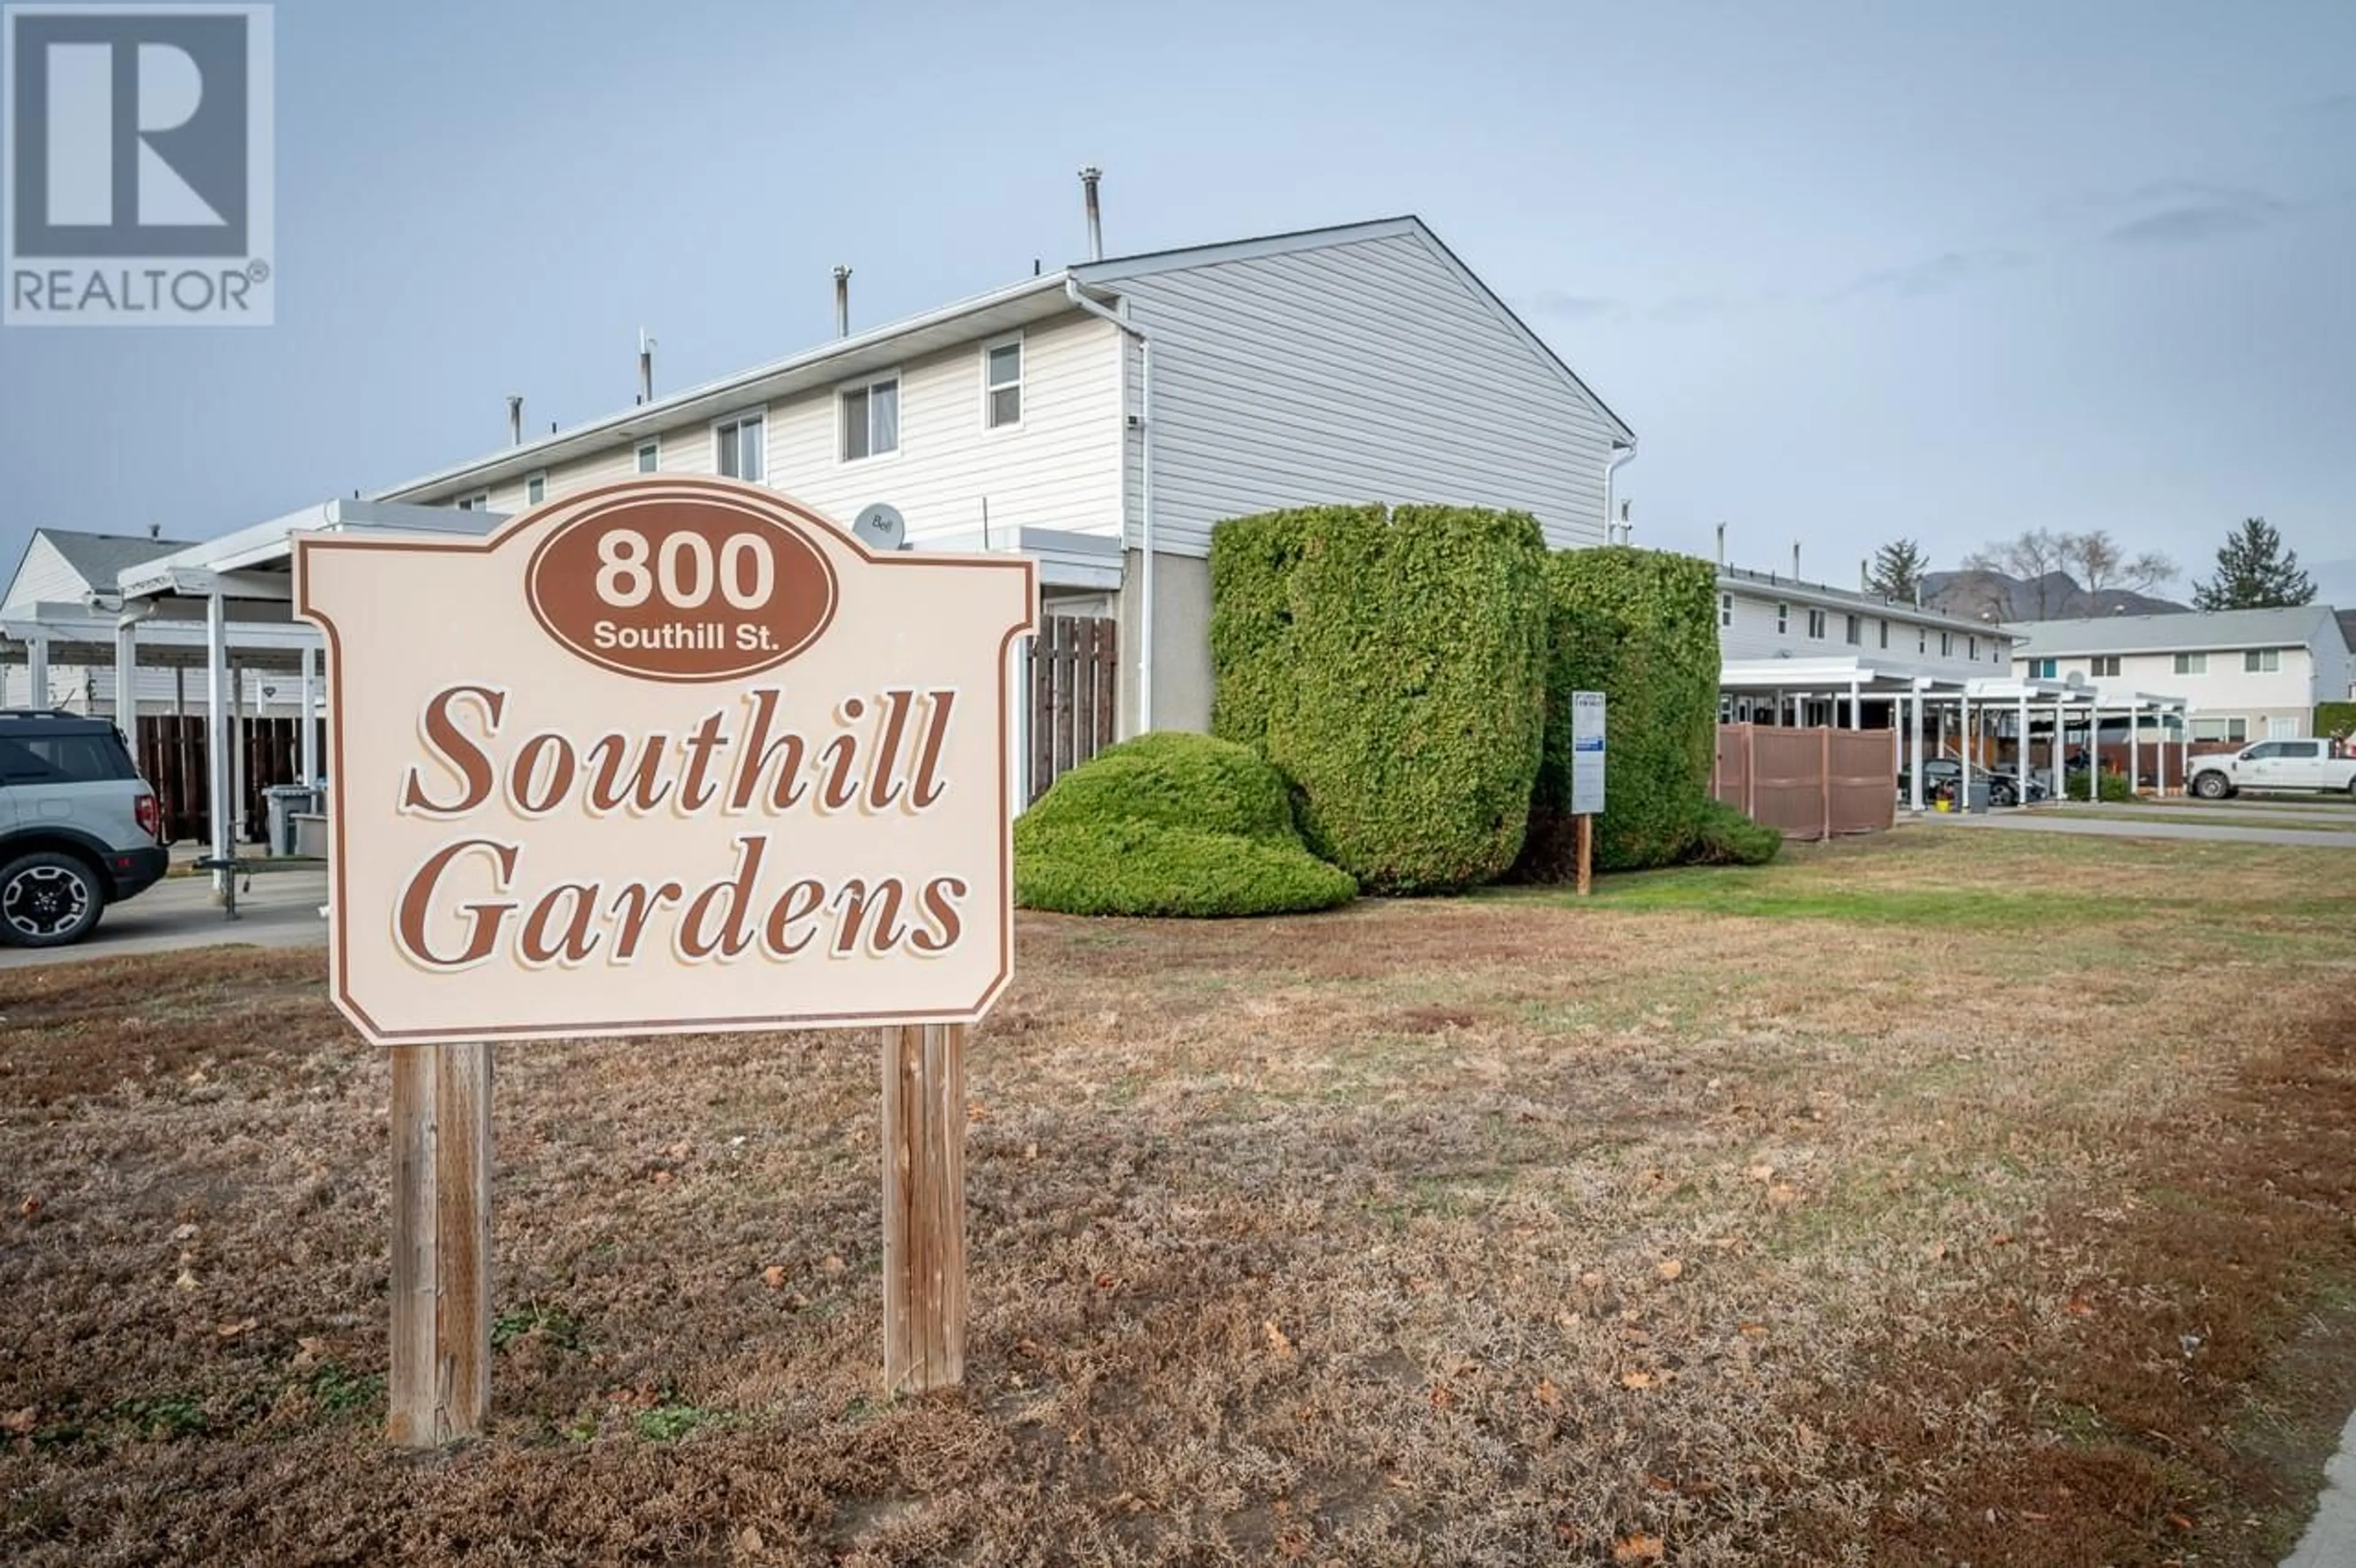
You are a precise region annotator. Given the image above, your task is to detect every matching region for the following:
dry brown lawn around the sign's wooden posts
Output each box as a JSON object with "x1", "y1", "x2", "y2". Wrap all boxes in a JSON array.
[{"x1": 0, "y1": 829, "x2": 2356, "y2": 1568}]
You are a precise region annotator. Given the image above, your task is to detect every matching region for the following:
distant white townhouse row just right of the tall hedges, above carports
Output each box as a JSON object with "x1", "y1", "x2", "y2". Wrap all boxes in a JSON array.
[{"x1": 1717, "y1": 565, "x2": 2012, "y2": 728}]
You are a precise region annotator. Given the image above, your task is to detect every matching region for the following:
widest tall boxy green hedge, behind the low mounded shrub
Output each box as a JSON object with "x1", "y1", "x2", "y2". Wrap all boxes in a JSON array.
[{"x1": 1211, "y1": 506, "x2": 1546, "y2": 894}]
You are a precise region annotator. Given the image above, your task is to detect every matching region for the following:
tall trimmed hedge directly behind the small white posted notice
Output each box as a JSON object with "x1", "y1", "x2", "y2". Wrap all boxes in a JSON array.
[{"x1": 1515, "y1": 546, "x2": 1717, "y2": 880}]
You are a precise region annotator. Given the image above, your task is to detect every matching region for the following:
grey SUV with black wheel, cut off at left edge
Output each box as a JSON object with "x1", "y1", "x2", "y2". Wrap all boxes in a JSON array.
[{"x1": 0, "y1": 711, "x2": 172, "y2": 947}]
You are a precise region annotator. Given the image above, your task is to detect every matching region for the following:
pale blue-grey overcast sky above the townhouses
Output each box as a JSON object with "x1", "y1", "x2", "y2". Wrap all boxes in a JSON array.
[{"x1": 0, "y1": 0, "x2": 2356, "y2": 602}]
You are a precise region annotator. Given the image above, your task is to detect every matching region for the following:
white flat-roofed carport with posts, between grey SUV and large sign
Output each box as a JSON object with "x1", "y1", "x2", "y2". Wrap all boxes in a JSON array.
[{"x1": 110, "y1": 499, "x2": 507, "y2": 888}]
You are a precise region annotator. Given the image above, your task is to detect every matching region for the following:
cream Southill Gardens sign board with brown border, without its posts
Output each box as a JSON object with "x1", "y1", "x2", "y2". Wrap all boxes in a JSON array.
[{"x1": 294, "y1": 478, "x2": 1037, "y2": 1045}]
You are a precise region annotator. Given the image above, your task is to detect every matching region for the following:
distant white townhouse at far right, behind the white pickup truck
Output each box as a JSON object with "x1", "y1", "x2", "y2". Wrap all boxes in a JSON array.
[{"x1": 2010, "y1": 605, "x2": 2351, "y2": 744}]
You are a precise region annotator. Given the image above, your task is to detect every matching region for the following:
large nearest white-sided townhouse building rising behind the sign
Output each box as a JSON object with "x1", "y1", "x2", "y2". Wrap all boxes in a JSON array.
[{"x1": 375, "y1": 217, "x2": 1635, "y2": 734}]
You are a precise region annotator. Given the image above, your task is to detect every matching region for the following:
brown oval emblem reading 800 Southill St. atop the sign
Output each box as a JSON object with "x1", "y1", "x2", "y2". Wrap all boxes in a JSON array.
[{"x1": 523, "y1": 497, "x2": 836, "y2": 680}]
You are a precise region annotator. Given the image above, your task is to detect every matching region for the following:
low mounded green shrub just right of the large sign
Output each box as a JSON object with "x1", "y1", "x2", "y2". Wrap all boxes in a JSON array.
[{"x1": 1015, "y1": 732, "x2": 1357, "y2": 918}]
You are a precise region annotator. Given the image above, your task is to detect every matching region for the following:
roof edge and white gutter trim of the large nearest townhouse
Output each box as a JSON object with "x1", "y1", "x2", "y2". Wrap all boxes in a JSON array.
[{"x1": 370, "y1": 217, "x2": 1635, "y2": 501}]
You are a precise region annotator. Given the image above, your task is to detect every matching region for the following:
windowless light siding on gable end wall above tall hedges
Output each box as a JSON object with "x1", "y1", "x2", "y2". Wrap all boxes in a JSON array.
[{"x1": 1112, "y1": 233, "x2": 1614, "y2": 556}]
